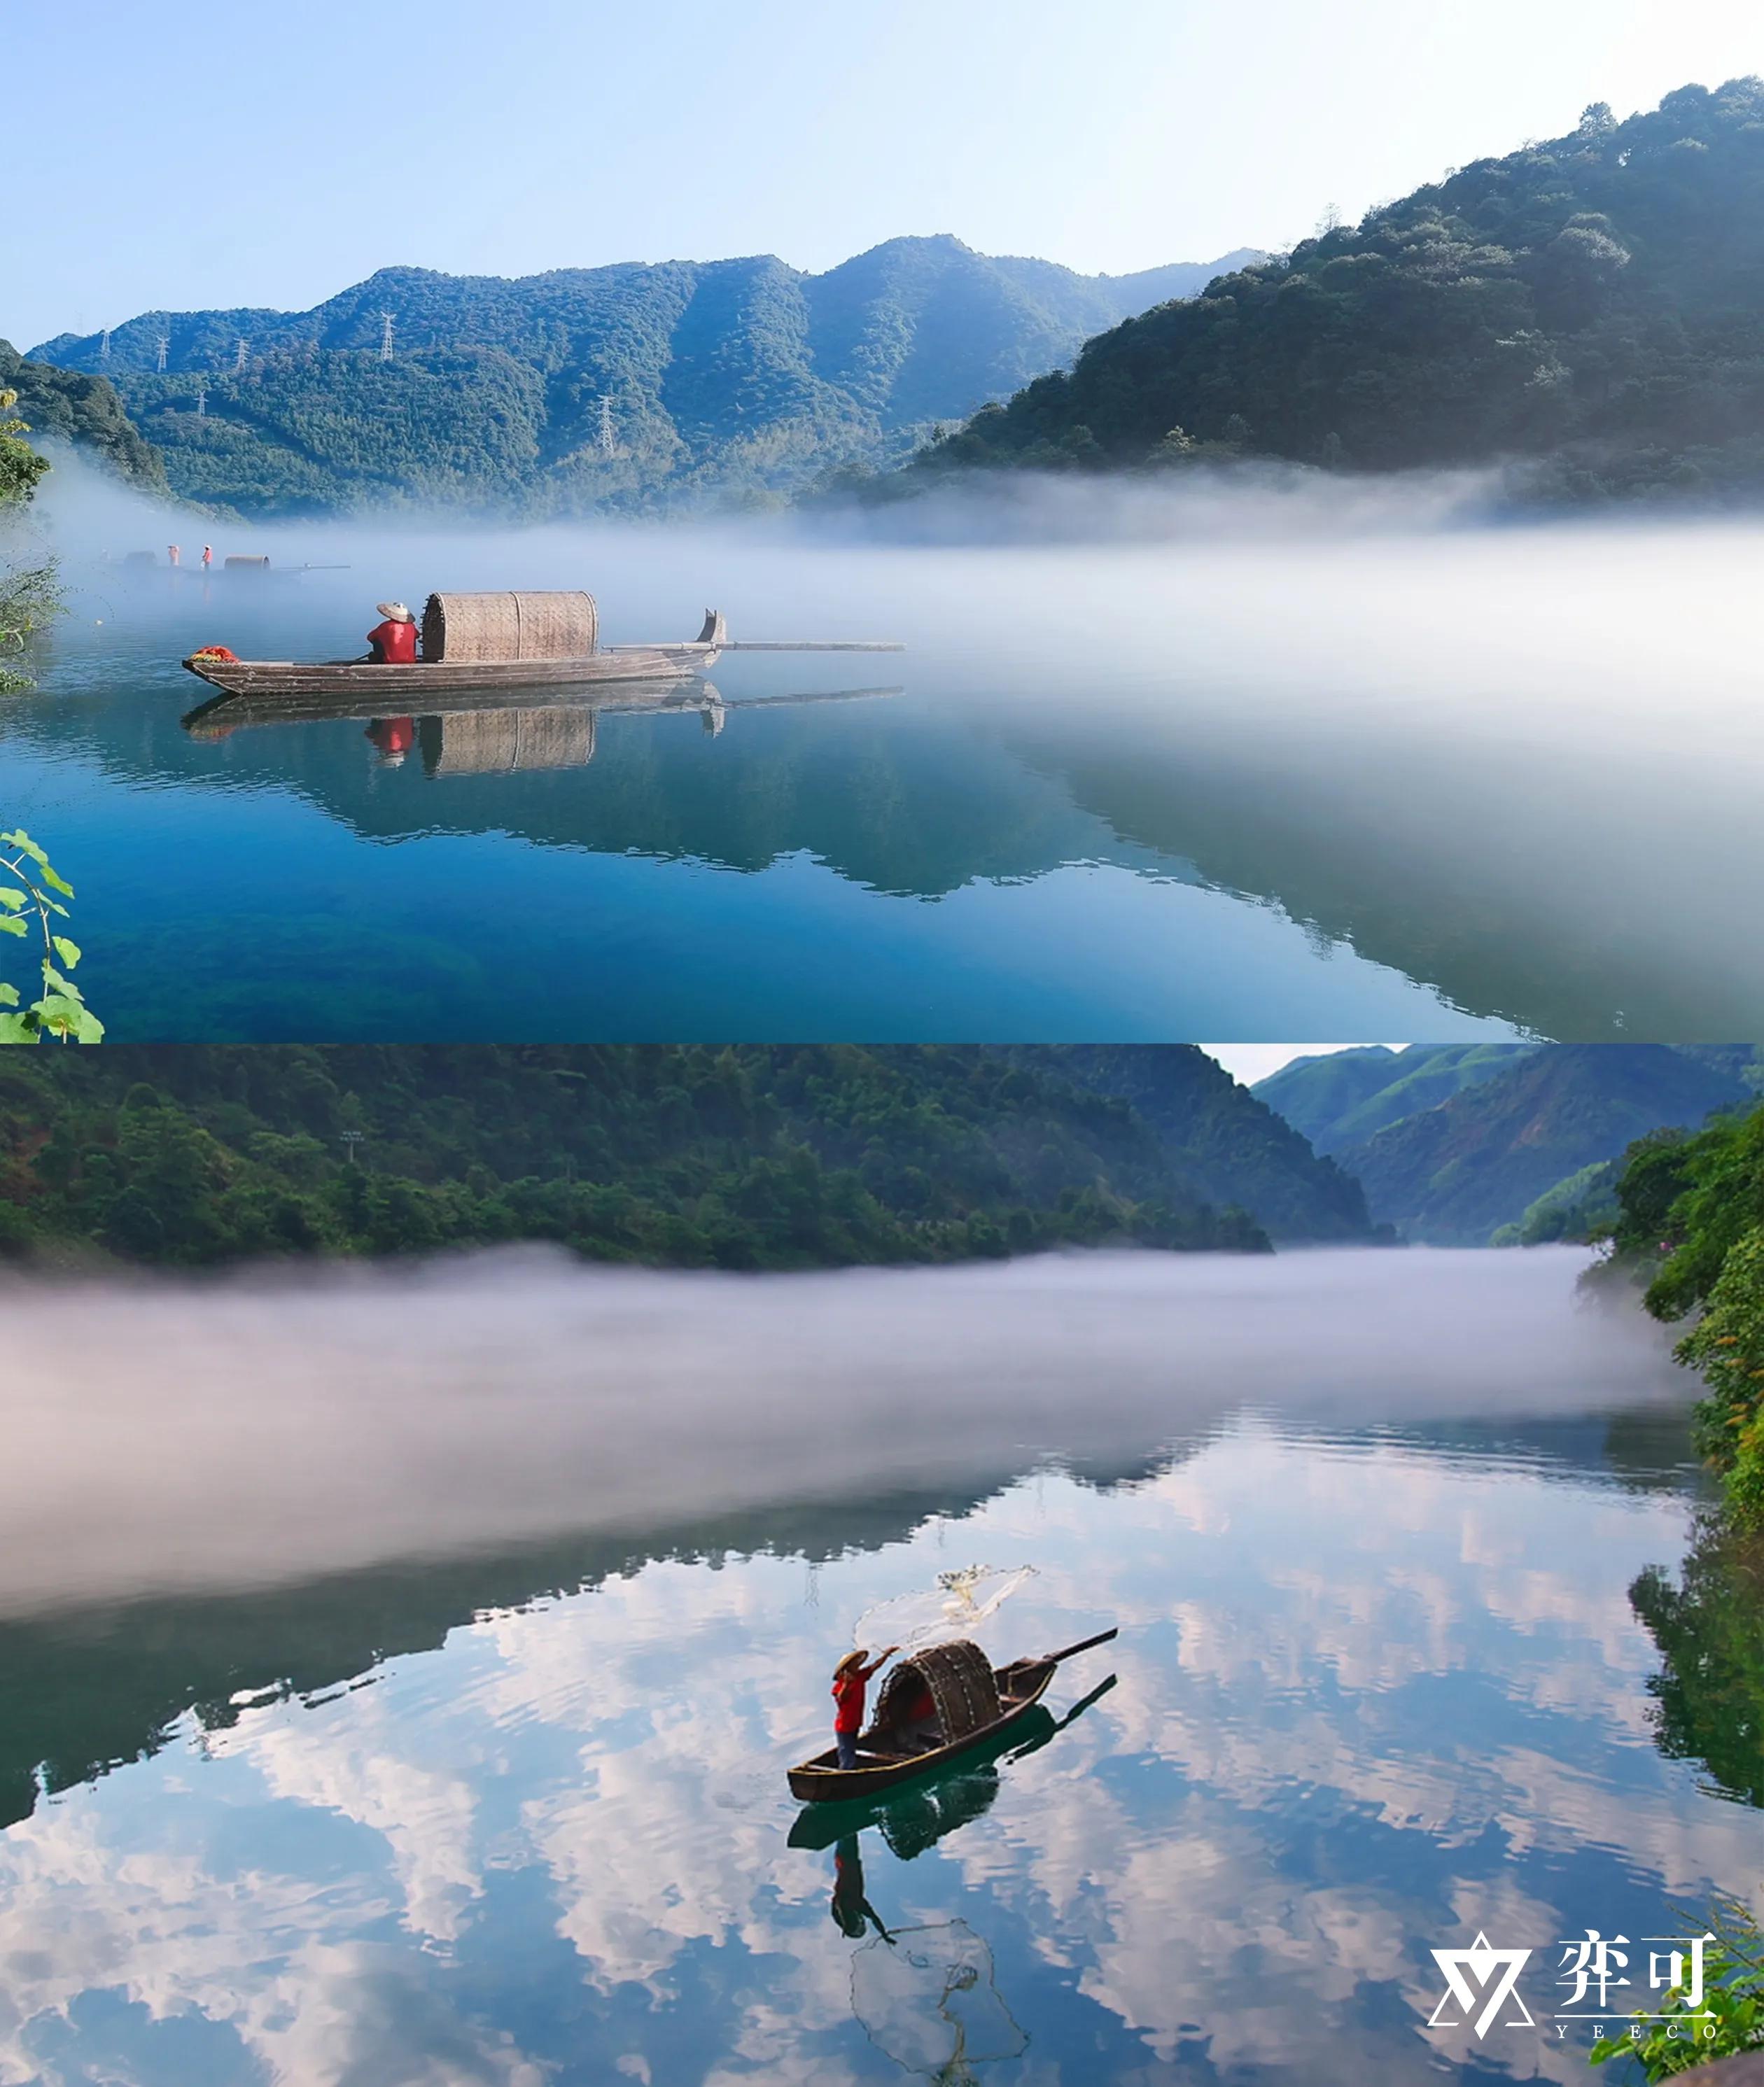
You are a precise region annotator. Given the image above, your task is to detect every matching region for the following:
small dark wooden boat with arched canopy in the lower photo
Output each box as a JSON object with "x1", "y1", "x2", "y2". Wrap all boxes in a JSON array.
[{"x1": 789, "y1": 1630, "x2": 1117, "y2": 1803}]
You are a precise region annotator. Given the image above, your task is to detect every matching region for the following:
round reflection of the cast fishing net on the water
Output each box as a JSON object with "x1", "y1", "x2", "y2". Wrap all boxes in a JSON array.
[{"x1": 852, "y1": 1920, "x2": 1029, "y2": 2087}]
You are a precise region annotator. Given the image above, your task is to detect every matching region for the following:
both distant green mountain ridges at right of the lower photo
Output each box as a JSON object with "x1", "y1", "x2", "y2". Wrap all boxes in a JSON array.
[{"x1": 1252, "y1": 1044, "x2": 1758, "y2": 1246}]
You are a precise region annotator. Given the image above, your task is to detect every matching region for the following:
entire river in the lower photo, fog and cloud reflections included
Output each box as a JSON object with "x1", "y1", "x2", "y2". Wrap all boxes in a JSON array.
[{"x1": 0, "y1": 1248, "x2": 1764, "y2": 2087}]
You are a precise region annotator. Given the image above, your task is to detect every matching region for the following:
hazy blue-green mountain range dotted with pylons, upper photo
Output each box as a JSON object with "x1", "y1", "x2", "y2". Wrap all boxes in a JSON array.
[{"x1": 38, "y1": 238, "x2": 1246, "y2": 514}]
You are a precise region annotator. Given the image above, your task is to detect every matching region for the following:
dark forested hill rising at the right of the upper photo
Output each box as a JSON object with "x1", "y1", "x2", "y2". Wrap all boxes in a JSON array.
[{"x1": 906, "y1": 77, "x2": 1764, "y2": 499}]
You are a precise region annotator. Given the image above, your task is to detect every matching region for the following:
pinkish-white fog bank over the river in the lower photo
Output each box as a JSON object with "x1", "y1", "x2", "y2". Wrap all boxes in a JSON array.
[{"x1": 0, "y1": 1248, "x2": 1693, "y2": 1615}]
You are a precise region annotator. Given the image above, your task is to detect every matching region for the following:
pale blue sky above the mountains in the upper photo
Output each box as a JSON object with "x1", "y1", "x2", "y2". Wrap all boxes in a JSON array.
[{"x1": 0, "y1": 0, "x2": 1764, "y2": 346}]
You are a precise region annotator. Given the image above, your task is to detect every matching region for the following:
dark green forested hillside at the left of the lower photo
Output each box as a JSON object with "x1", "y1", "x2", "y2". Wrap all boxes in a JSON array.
[{"x1": 0, "y1": 1046, "x2": 1267, "y2": 1269}]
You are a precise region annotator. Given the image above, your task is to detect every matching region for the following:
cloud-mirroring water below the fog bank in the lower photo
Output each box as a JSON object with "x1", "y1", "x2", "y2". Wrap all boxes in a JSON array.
[{"x1": 0, "y1": 1256, "x2": 1764, "y2": 2087}]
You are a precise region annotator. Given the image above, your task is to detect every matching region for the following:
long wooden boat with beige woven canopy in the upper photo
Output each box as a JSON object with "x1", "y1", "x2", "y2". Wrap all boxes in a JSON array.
[{"x1": 183, "y1": 593, "x2": 904, "y2": 712}]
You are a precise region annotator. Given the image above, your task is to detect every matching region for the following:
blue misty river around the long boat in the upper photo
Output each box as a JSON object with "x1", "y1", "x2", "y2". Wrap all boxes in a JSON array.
[{"x1": 13, "y1": 465, "x2": 1764, "y2": 1041}]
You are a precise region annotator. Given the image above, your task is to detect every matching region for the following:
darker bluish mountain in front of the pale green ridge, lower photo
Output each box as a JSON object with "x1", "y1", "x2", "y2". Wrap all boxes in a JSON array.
[{"x1": 1336, "y1": 1044, "x2": 1754, "y2": 1246}]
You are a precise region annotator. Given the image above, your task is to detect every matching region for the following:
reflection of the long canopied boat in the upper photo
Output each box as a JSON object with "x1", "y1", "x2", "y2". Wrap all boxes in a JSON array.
[{"x1": 181, "y1": 676, "x2": 899, "y2": 776}]
